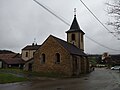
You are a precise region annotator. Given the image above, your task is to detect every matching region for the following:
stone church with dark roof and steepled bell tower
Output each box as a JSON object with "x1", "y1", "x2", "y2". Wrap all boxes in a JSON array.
[{"x1": 33, "y1": 11, "x2": 89, "y2": 76}]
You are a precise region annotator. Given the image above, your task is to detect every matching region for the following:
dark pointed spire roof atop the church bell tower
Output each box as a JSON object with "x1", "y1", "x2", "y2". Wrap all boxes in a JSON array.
[{"x1": 66, "y1": 15, "x2": 85, "y2": 34}]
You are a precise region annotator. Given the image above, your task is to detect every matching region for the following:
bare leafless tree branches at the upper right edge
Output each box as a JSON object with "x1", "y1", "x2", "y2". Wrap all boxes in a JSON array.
[{"x1": 106, "y1": 0, "x2": 120, "y2": 34}]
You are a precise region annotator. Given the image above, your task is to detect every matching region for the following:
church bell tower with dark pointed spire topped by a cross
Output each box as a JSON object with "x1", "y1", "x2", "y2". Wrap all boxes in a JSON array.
[{"x1": 66, "y1": 8, "x2": 85, "y2": 51}]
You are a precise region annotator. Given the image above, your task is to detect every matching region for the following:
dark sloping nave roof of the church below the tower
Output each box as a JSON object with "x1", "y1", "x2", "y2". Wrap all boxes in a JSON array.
[{"x1": 50, "y1": 35, "x2": 87, "y2": 56}]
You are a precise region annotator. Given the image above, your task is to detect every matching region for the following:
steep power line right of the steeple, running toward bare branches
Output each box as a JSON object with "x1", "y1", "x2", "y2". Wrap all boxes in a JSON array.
[{"x1": 80, "y1": 0, "x2": 116, "y2": 37}]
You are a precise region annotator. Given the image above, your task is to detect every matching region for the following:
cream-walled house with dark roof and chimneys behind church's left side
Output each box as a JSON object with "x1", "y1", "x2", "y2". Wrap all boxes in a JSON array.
[{"x1": 22, "y1": 43, "x2": 40, "y2": 61}]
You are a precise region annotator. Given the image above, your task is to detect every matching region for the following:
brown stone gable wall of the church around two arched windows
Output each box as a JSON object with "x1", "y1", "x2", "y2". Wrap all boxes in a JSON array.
[{"x1": 33, "y1": 37, "x2": 72, "y2": 76}]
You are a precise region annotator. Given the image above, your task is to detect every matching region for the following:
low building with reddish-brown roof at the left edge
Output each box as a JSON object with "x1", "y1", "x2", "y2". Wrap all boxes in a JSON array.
[{"x1": 0, "y1": 53, "x2": 25, "y2": 69}]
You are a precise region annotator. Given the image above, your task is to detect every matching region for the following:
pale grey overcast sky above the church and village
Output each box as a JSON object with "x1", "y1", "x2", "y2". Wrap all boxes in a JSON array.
[{"x1": 0, "y1": 0, "x2": 120, "y2": 54}]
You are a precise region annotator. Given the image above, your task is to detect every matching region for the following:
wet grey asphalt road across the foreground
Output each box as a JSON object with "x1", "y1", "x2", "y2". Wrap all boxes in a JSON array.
[{"x1": 0, "y1": 68, "x2": 120, "y2": 90}]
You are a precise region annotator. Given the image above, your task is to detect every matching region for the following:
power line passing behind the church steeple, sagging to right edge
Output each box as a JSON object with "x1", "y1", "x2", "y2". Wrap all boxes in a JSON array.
[{"x1": 33, "y1": 0, "x2": 120, "y2": 51}]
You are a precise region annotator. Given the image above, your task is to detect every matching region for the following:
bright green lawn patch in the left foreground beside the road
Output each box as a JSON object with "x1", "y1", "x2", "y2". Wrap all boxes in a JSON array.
[{"x1": 0, "y1": 73, "x2": 27, "y2": 84}]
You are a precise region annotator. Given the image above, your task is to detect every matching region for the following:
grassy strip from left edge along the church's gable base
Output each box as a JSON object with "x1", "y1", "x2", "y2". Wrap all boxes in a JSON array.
[{"x1": 0, "y1": 69, "x2": 65, "y2": 84}]
